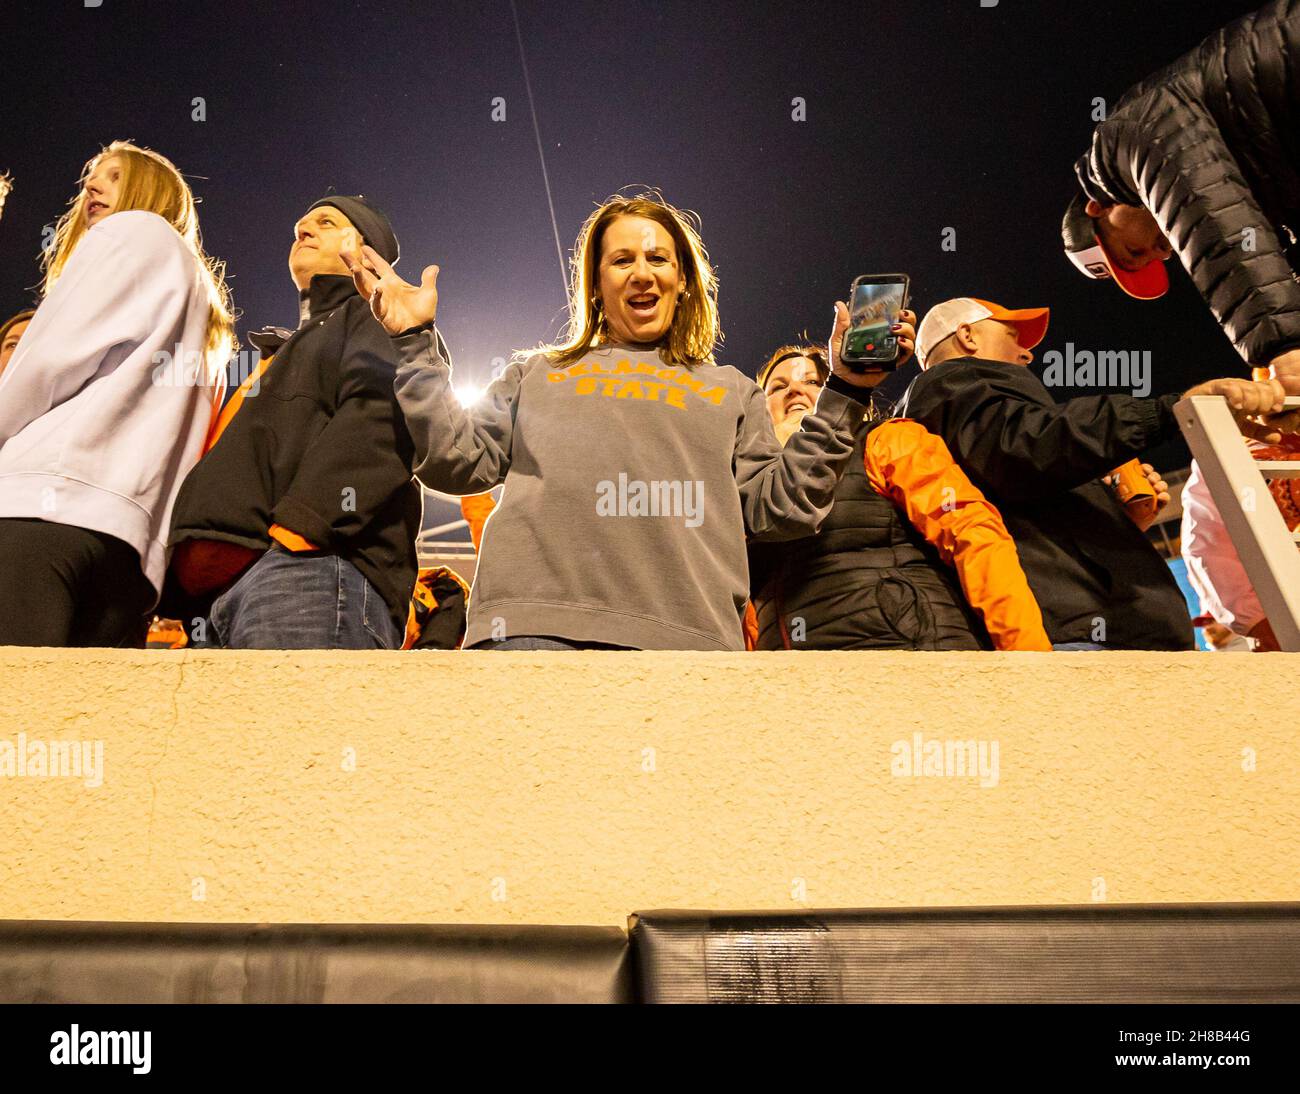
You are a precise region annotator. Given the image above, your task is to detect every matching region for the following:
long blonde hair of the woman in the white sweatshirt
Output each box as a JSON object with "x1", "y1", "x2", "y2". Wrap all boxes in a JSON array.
[{"x1": 40, "y1": 140, "x2": 235, "y2": 378}]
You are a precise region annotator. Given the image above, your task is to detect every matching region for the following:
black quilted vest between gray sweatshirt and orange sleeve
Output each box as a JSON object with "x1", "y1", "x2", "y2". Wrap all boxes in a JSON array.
[{"x1": 749, "y1": 421, "x2": 993, "y2": 650}]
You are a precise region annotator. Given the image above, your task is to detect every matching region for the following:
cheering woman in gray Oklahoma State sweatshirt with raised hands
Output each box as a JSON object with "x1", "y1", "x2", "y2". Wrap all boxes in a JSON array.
[{"x1": 348, "y1": 195, "x2": 911, "y2": 650}]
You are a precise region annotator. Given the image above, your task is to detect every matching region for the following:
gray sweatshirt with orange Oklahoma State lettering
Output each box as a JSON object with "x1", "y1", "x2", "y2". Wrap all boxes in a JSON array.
[{"x1": 394, "y1": 331, "x2": 865, "y2": 650}]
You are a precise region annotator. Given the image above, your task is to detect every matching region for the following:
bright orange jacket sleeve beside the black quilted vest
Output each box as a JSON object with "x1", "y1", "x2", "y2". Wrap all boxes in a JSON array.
[{"x1": 866, "y1": 418, "x2": 1052, "y2": 650}]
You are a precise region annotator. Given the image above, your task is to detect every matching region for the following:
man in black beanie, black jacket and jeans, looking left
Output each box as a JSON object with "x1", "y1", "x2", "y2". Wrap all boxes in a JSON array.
[{"x1": 163, "y1": 195, "x2": 431, "y2": 650}]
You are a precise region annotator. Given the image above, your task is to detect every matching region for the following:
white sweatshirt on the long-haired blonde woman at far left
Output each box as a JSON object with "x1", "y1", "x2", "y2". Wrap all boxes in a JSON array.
[{"x1": 0, "y1": 212, "x2": 225, "y2": 590}]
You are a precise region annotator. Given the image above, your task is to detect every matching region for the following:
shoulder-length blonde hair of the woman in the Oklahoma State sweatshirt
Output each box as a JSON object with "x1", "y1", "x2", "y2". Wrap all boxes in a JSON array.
[{"x1": 535, "y1": 190, "x2": 723, "y2": 368}]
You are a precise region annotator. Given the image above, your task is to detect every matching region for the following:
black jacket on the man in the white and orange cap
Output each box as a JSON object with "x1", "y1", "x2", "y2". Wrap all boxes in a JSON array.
[{"x1": 900, "y1": 357, "x2": 1192, "y2": 650}]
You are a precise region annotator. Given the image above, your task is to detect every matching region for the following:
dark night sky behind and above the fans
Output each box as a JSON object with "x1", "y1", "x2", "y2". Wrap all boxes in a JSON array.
[{"x1": 0, "y1": 0, "x2": 1257, "y2": 466}]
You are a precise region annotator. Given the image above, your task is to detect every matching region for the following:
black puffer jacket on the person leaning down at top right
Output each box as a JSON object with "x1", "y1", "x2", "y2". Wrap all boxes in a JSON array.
[{"x1": 1076, "y1": 0, "x2": 1300, "y2": 365}]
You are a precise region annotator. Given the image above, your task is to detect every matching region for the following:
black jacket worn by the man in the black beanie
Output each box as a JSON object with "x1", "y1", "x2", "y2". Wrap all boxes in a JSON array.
[{"x1": 170, "y1": 275, "x2": 421, "y2": 630}]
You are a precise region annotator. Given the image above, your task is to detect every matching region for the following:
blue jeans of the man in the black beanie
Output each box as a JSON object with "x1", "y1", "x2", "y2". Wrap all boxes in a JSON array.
[{"x1": 208, "y1": 546, "x2": 402, "y2": 650}]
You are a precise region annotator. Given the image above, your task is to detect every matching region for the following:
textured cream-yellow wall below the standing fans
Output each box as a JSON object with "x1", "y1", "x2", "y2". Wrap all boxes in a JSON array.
[{"x1": 0, "y1": 648, "x2": 1300, "y2": 925}]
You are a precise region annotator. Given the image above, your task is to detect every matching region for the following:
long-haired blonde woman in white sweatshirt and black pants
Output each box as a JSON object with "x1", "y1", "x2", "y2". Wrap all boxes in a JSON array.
[{"x1": 0, "y1": 142, "x2": 234, "y2": 646}]
